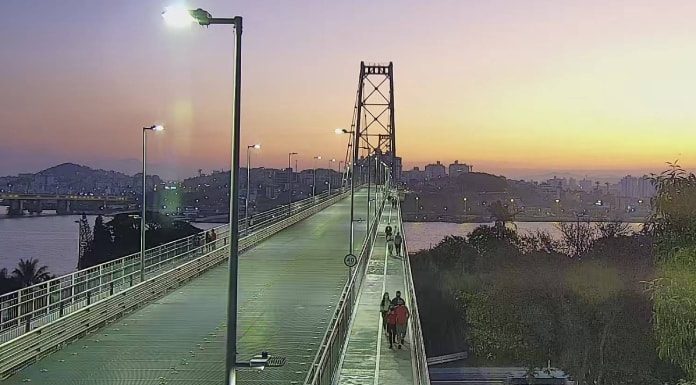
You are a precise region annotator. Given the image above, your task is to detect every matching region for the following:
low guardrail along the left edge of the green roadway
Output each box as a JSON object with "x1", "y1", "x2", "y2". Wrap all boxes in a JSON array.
[{"x1": 0, "y1": 187, "x2": 348, "y2": 380}]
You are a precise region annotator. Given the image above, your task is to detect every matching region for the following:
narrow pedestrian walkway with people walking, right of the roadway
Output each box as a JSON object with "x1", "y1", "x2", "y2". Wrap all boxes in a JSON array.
[{"x1": 338, "y1": 205, "x2": 413, "y2": 385}]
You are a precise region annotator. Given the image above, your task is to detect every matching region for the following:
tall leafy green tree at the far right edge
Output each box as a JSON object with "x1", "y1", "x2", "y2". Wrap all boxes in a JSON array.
[{"x1": 649, "y1": 164, "x2": 696, "y2": 382}]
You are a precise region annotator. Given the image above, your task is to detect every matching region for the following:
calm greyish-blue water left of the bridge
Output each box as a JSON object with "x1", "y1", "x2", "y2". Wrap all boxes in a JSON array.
[{"x1": 0, "y1": 207, "x2": 219, "y2": 275}]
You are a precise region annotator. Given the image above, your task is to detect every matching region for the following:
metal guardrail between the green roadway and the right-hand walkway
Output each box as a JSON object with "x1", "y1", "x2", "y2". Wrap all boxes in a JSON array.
[{"x1": 304, "y1": 184, "x2": 385, "y2": 385}]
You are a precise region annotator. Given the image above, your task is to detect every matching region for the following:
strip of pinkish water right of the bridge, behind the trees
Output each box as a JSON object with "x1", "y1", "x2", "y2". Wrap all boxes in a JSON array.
[{"x1": 404, "y1": 222, "x2": 642, "y2": 251}]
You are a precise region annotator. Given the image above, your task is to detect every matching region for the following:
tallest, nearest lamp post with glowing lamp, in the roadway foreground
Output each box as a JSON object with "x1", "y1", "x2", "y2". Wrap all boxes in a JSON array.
[{"x1": 162, "y1": 7, "x2": 242, "y2": 385}]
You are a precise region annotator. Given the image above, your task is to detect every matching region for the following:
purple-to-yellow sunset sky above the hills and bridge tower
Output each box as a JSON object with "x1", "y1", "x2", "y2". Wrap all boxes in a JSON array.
[{"x1": 0, "y1": 0, "x2": 696, "y2": 178}]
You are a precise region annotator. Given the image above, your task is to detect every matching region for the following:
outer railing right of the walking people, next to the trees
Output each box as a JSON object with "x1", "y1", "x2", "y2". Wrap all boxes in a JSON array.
[{"x1": 398, "y1": 196, "x2": 430, "y2": 385}]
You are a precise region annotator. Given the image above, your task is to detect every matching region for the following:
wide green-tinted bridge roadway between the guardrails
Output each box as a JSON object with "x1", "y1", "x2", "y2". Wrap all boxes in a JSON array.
[{"x1": 3, "y1": 192, "x2": 366, "y2": 385}]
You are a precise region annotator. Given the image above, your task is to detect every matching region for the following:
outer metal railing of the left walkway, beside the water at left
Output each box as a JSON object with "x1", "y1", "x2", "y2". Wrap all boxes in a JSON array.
[{"x1": 0, "y1": 189, "x2": 344, "y2": 344}]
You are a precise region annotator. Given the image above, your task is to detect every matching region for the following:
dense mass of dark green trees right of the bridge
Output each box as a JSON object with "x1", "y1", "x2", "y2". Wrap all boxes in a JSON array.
[{"x1": 412, "y1": 166, "x2": 696, "y2": 385}]
